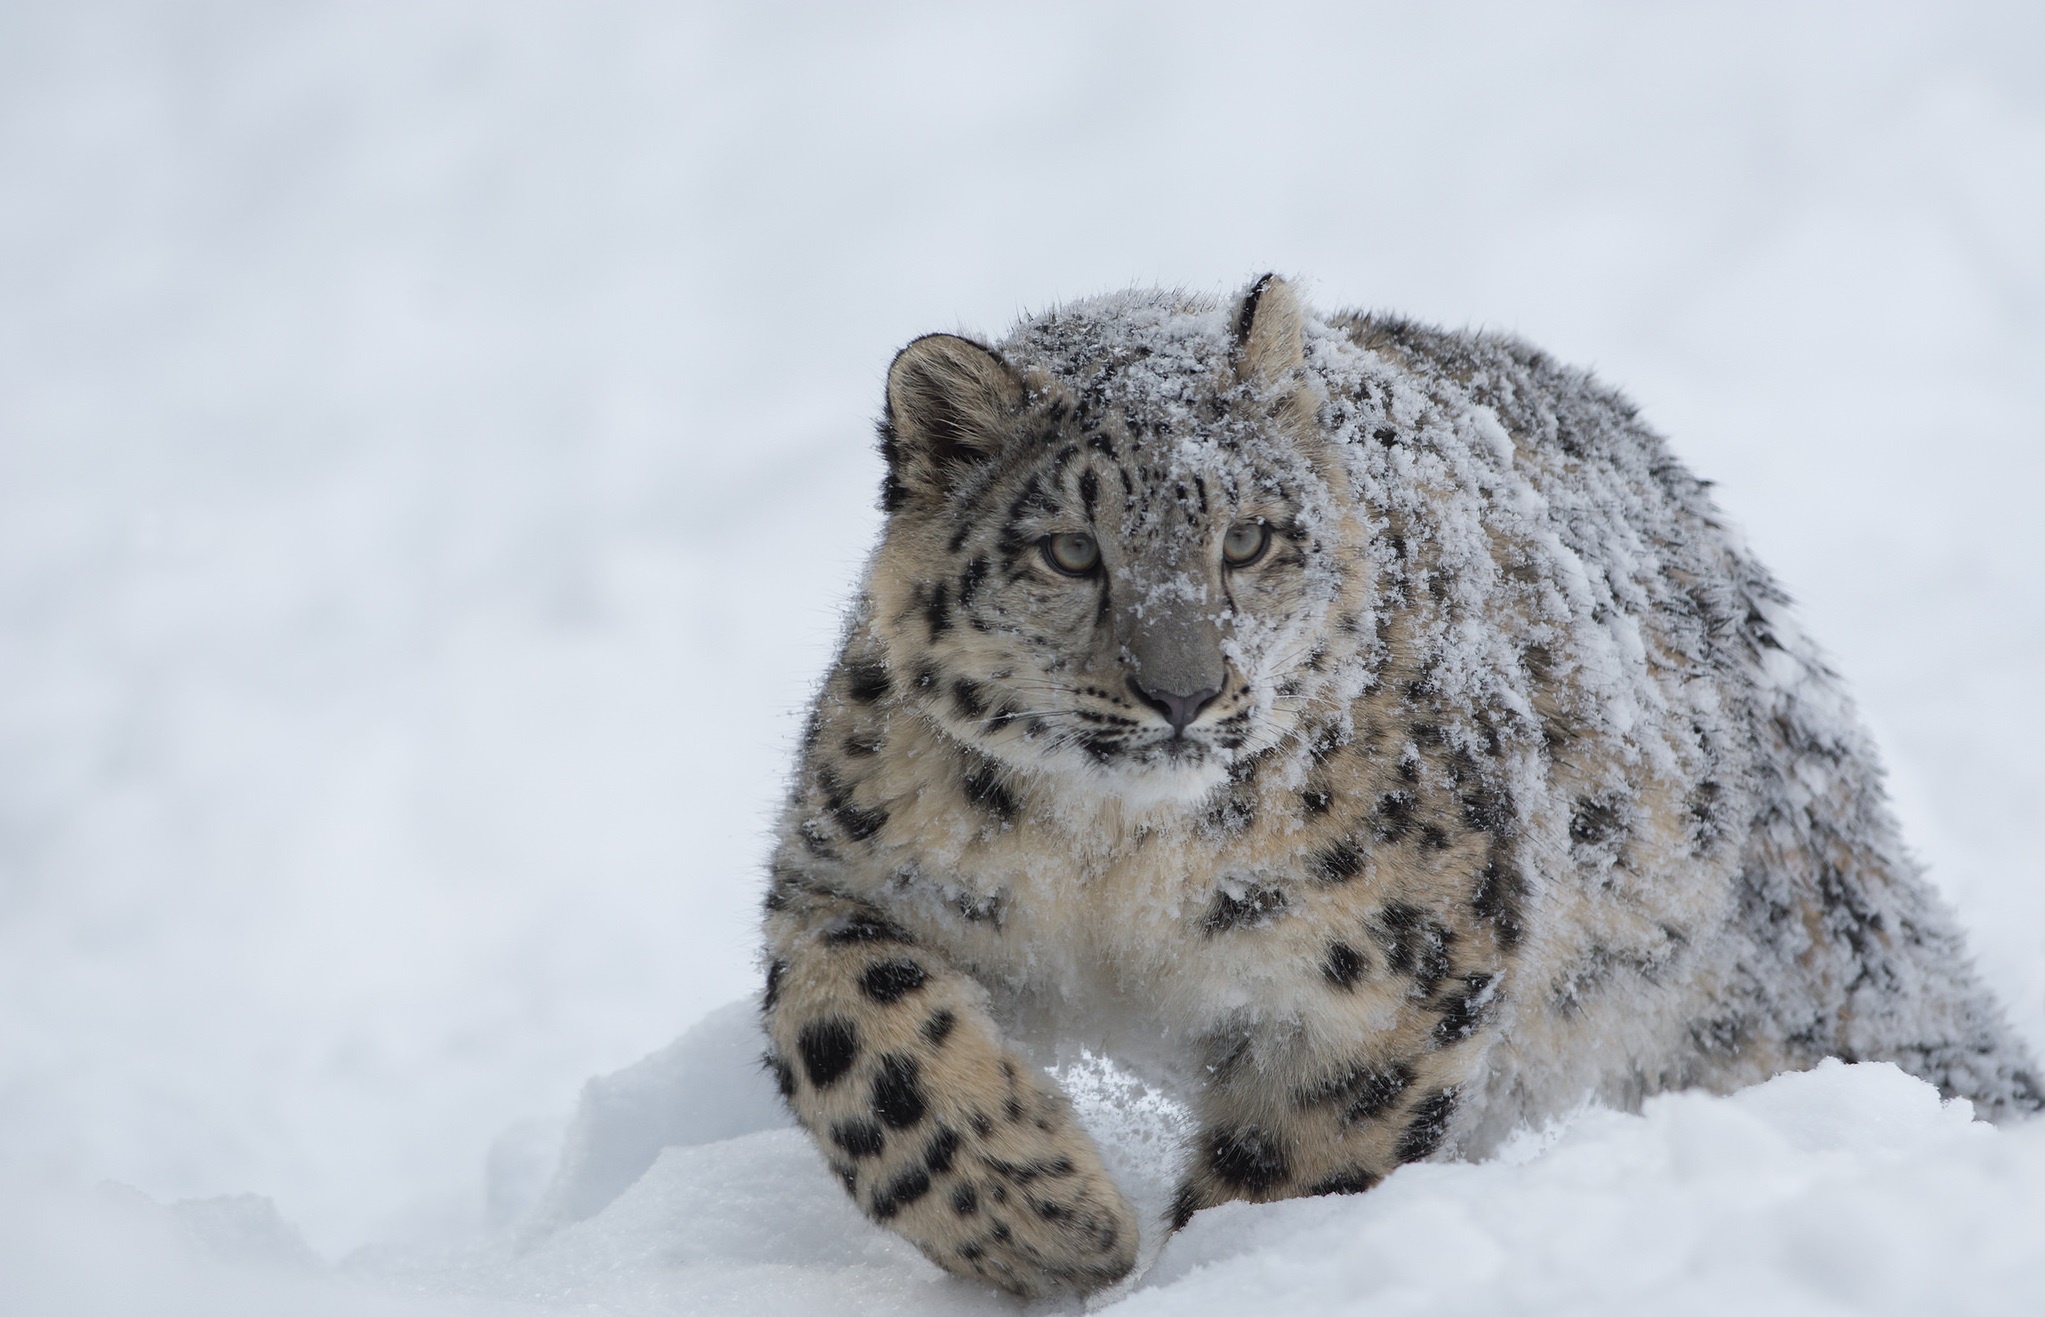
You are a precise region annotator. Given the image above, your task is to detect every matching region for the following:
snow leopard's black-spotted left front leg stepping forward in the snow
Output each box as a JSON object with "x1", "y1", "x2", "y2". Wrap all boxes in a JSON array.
[{"x1": 765, "y1": 881, "x2": 1137, "y2": 1295}]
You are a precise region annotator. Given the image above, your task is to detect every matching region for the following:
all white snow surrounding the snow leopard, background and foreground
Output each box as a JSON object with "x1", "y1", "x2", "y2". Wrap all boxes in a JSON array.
[{"x1": 0, "y1": 0, "x2": 2045, "y2": 1315}]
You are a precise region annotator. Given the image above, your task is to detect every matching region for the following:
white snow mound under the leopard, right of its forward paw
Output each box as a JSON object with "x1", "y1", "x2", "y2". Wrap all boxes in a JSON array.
[{"x1": 1123, "y1": 1061, "x2": 2045, "y2": 1317}]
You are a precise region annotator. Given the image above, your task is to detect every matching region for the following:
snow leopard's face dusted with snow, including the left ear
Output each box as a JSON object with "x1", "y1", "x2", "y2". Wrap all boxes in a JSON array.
[{"x1": 873, "y1": 300, "x2": 1354, "y2": 804}]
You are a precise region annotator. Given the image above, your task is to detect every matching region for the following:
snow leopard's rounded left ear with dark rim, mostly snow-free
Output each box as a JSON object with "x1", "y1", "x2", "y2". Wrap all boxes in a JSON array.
[{"x1": 881, "y1": 333, "x2": 1027, "y2": 511}]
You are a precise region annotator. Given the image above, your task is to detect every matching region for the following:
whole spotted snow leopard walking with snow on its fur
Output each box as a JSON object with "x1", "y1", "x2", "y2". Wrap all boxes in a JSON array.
[{"x1": 761, "y1": 276, "x2": 2045, "y2": 1295}]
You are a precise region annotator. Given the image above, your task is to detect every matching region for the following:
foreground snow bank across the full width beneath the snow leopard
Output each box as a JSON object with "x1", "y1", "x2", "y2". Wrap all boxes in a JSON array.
[{"x1": 0, "y1": 1002, "x2": 2045, "y2": 1317}]
